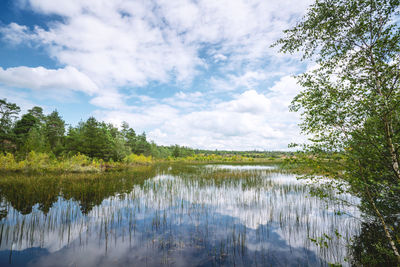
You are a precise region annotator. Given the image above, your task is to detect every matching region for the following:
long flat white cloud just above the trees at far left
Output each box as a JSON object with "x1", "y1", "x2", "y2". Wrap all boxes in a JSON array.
[{"x1": 0, "y1": 66, "x2": 98, "y2": 95}]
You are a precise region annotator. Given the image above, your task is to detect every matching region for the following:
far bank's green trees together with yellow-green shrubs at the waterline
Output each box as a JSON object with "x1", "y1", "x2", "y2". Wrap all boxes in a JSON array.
[{"x1": 0, "y1": 100, "x2": 290, "y2": 172}]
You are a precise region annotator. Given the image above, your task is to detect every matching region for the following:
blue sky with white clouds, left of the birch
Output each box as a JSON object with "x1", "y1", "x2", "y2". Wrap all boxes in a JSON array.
[{"x1": 0, "y1": 0, "x2": 311, "y2": 150}]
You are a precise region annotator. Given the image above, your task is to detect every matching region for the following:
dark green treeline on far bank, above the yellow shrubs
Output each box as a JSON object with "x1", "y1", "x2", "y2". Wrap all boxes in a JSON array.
[{"x1": 0, "y1": 99, "x2": 286, "y2": 161}]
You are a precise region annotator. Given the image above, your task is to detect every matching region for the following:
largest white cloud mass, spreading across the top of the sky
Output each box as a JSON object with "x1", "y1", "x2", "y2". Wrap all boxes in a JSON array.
[{"x1": 2, "y1": 0, "x2": 310, "y2": 90}]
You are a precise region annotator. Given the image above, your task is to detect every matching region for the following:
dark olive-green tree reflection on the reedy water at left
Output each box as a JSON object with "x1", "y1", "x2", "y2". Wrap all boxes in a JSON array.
[{"x1": 0, "y1": 166, "x2": 162, "y2": 217}]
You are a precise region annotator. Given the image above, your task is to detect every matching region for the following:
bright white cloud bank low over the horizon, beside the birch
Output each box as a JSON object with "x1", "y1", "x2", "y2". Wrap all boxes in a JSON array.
[{"x1": 97, "y1": 77, "x2": 304, "y2": 150}]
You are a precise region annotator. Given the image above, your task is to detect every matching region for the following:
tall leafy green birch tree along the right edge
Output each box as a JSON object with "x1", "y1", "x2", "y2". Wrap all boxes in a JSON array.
[{"x1": 275, "y1": 0, "x2": 400, "y2": 265}]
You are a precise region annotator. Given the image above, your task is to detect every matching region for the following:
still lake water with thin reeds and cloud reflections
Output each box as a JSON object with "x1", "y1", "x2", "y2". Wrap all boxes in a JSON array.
[{"x1": 0, "y1": 165, "x2": 360, "y2": 266}]
